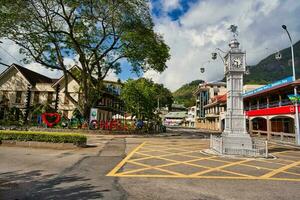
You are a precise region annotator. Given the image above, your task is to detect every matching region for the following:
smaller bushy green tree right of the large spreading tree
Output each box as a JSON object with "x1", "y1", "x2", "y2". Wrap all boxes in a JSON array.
[{"x1": 121, "y1": 78, "x2": 173, "y2": 120}]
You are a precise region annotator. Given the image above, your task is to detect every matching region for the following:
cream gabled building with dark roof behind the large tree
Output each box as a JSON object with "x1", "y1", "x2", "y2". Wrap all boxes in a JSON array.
[{"x1": 0, "y1": 64, "x2": 124, "y2": 120}]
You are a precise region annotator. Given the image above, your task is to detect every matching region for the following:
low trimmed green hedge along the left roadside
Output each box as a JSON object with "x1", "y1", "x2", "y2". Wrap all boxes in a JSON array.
[{"x1": 0, "y1": 130, "x2": 87, "y2": 145}]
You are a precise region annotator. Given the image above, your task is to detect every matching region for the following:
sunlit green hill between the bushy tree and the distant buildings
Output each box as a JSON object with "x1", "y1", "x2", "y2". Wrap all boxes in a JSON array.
[{"x1": 173, "y1": 80, "x2": 204, "y2": 107}]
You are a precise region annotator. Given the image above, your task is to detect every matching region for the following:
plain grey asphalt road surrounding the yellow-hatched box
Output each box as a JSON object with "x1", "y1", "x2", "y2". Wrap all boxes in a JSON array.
[{"x1": 0, "y1": 129, "x2": 300, "y2": 200}]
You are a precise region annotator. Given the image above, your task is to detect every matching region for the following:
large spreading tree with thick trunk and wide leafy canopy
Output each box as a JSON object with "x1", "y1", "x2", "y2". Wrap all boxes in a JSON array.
[{"x1": 0, "y1": 0, "x2": 169, "y2": 119}]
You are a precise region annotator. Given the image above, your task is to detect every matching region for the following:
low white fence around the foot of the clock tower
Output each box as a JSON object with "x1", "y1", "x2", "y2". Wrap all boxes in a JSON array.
[{"x1": 210, "y1": 135, "x2": 268, "y2": 157}]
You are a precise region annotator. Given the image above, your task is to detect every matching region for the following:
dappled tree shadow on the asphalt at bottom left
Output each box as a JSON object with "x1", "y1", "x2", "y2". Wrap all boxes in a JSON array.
[{"x1": 0, "y1": 170, "x2": 107, "y2": 200}]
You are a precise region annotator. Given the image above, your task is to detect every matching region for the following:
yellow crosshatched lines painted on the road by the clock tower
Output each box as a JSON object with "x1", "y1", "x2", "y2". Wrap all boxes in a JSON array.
[{"x1": 107, "y1": 142, "x2": 300, "y2": 181}]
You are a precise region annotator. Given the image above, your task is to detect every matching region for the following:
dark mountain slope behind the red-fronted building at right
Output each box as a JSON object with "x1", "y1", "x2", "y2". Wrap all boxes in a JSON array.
[{"x1": 244, "y1": 41, "x2": 300, "y2": 84}]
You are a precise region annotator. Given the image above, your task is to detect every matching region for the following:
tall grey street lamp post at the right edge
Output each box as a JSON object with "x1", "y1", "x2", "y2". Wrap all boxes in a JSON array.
[{"x1": 282, "y1": 25, "x2": 300, "y2": 145}]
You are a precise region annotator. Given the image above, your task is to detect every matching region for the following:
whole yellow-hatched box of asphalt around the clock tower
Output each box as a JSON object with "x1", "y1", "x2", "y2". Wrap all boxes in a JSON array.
[{"x1": 107, "y1": 140, "x2": 300, "y2": 181}]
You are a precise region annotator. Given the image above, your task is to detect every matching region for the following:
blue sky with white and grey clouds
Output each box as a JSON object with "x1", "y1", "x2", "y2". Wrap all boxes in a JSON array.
[{"x1": 0, "y1": 0, "x2": 300, "y2": 91}]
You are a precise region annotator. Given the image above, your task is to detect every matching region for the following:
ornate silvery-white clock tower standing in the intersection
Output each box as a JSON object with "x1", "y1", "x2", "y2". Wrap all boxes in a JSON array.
[{"x1": 222, "y1": 37, "x2": 252, "y2": 150}]
